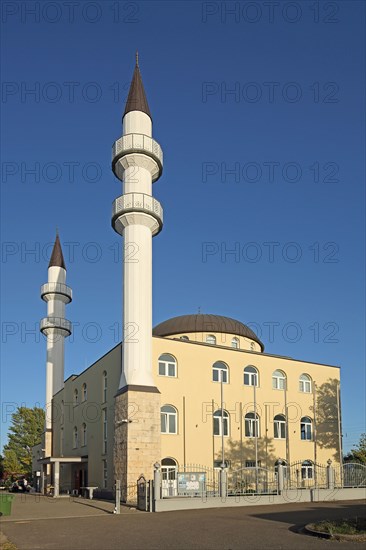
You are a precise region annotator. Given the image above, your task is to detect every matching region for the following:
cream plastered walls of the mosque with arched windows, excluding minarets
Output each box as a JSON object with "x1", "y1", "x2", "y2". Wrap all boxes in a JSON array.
[{"x1": 47, "y1": 332, "x2": 340, "y2": 496}]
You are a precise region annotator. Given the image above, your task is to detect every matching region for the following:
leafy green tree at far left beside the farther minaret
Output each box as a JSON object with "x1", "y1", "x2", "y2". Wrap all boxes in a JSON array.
[{"x1": 4, "y1": 407, "x2": 45, "y2": 476}]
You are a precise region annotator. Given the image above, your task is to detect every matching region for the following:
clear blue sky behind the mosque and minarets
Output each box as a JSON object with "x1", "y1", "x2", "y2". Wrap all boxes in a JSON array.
[{"x1": 1, "y1": 1, "x2": 365, "y2": 458}]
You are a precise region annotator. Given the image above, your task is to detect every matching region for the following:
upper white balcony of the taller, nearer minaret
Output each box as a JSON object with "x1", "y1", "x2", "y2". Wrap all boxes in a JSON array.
[{"x1": 112, "y1": 134, "x2": 163, "y2": 182}]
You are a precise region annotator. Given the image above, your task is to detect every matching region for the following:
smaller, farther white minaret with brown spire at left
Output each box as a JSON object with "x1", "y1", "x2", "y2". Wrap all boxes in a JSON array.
[{"x1": 40, "y1": 234, "x2": 72, "y2": 456}]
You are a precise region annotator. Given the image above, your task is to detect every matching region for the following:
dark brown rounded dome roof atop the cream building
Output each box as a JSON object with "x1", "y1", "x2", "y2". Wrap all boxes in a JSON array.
[{"x1": 153, "y1": 313, "x2": 264, "y2": 351}]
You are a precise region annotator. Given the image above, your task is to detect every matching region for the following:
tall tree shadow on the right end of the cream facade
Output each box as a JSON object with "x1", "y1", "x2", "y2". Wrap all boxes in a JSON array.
[{"x1": 312, "y1": 378, "x2": 340, "y2": 462}]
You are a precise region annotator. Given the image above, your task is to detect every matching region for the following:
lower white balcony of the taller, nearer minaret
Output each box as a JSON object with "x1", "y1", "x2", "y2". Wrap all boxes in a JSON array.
[{"x1": 112, "y1": 193, "x2": 163, "y2": 235}]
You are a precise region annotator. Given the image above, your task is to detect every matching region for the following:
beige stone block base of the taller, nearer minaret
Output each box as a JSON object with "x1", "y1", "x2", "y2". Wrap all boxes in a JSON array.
[{"x1": 114, "y1": 386, "x2": 161, "y2": 504}]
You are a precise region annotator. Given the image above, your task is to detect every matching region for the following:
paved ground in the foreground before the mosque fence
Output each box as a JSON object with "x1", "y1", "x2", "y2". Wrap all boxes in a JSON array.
[{"x1": 2, "y1": 495, "x2": 365, "y2": 550}]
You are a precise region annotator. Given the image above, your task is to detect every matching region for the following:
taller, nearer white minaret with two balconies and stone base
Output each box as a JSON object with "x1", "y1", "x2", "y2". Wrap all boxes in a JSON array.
[{"x1": 112, "y1": 54, "x2": 163, "y2": 504}]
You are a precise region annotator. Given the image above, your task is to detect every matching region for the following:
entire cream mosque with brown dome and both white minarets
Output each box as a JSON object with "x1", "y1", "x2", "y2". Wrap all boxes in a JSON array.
[{"x1": 33, "y1": 59, "x2": 342, "y2": 501}]
